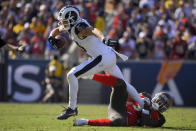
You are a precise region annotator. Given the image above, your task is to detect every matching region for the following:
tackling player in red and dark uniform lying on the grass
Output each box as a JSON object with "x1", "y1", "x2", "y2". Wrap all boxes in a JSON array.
[{"x1": 74, "y1": 74, "x2": 172, "y2": 127}]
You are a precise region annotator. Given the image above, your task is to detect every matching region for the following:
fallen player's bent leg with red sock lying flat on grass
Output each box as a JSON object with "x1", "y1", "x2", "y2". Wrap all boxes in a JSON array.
[{"x1": 74, "y1": 77, "x2": 128, "y2": 126}]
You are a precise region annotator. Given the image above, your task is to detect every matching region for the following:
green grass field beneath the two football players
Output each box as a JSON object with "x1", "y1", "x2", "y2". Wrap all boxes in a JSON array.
[{"x1": 0, "y1": 103, "x2": 196, "y2": 131}]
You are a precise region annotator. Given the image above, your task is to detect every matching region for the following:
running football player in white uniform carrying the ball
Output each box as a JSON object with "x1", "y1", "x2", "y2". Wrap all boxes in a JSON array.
[{"x1": 48, "y1": 5, "x2": 144, "y2": 120}]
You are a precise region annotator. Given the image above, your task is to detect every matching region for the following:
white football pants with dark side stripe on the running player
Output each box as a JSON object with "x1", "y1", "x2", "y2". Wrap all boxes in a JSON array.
[{"x1": 67, "y1": 50, "x2": 144, "y2": 109}]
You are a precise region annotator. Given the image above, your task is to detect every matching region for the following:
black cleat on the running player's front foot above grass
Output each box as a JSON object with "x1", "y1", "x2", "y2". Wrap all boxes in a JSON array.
[{"x1": 57, "y1": 107, "x2": 78, "y2": 120}]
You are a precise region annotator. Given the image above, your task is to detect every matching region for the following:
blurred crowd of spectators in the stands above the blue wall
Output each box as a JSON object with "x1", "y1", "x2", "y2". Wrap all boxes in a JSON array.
[{"x1": 0, "y1": 0, "x2": 196, "y2": 60}]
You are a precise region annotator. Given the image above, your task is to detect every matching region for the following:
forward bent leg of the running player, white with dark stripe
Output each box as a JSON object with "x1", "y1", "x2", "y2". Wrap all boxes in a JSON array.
[{"x1": 57, "y1": 55, "x2": 103, "y2": 120}]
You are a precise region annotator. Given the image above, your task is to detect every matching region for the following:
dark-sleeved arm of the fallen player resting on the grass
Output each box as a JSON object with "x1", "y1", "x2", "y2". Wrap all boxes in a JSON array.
[{"x1": 141, "y1": 112, "x2": 165, "y2": 127}]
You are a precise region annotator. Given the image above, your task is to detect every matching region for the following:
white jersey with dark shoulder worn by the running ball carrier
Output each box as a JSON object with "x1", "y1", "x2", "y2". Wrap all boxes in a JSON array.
[{"x1": 71, "y1": 19, "x2": 111, "y2": 57}]
